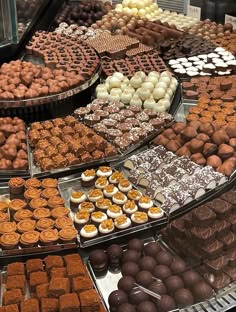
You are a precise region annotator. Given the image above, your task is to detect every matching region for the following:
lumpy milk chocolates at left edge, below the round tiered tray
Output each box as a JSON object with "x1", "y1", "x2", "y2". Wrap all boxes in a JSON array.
[{"x1": 0, "y1": 117, "x2": 28, "y2": 170}]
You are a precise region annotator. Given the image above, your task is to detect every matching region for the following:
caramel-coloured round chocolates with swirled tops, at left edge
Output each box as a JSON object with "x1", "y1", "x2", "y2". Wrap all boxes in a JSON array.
[{"x1": 0, "y1": 177, "x2": 77, "y2": 250}]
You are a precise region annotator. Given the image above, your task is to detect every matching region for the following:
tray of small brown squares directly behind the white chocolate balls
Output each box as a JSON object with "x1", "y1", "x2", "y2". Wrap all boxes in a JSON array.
[{"x1": 102, "y1": 50, "x2": 168, "y2": 79}]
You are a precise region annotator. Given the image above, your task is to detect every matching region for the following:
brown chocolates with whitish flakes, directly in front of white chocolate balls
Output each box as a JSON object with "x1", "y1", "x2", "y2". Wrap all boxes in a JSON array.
[{"x1": 74, "y1": 99, "x2": 173, "y2": 152}]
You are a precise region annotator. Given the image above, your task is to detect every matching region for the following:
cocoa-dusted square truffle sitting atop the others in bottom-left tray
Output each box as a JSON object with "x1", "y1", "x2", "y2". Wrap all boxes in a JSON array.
[{"x1": 49, "y1": 277, "x2": 70, "y2": 298}]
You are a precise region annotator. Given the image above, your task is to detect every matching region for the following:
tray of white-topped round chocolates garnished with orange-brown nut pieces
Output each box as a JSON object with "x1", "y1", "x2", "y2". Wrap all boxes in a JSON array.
[{"x1": 68, "y1": 166, "x2": 164, "y2": 244}]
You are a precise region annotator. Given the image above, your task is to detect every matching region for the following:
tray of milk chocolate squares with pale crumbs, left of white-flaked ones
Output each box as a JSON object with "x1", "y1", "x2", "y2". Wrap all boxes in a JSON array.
[{"x1": 29, "y1": 116, "x2": 117, "y2": 171}]
